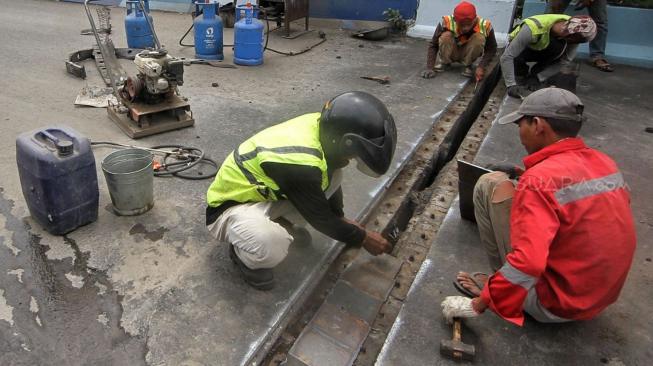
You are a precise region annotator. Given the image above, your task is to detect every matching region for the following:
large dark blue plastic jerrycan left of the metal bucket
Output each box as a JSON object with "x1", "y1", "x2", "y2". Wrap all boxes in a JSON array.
[{"x1": 16, "y1": 127, "x2": 99, "y2": 235}]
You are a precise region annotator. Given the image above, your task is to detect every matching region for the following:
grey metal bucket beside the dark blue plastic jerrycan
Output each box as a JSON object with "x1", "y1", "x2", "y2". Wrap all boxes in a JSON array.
[{"x1": 102, "y1": 149, "x2": 154, "y2": 216}]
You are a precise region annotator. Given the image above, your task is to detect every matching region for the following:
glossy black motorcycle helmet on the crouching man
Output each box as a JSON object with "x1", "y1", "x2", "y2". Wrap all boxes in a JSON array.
[{"x1": 320, "y1": 91, "x2": 397, "y2": 177}]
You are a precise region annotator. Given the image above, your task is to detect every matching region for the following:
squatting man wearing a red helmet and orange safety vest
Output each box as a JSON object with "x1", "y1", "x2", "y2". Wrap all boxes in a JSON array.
[{"x1": 422, "y1": 1, "x2": 497, "y2": 81}]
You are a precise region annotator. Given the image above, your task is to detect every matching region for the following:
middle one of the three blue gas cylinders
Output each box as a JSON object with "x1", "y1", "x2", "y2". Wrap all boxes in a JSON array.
[{"x1": 193, "y1": 1, "x2": 224, "y2": 60}]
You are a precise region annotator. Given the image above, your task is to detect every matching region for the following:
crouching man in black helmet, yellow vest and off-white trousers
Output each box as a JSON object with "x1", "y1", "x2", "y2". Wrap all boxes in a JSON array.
[{"x1": 206, "y1": 92, "x2": 397, "y2": 290}]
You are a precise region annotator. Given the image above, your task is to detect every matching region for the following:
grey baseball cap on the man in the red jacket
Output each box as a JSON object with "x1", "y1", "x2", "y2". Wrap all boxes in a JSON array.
[{"x1": 499, "y1": 87, "x2": 584, "y2": 125}]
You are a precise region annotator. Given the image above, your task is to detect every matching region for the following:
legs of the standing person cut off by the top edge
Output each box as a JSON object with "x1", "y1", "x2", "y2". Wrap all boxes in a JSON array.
[{"x1": 546, "y1": 0, "x2": 614, "y2": 72}]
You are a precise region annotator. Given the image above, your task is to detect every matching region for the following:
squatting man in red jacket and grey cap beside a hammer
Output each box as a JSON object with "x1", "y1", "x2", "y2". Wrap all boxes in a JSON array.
[{"x1": 442, "y1": 88, "x2": 636, "y2": 325}]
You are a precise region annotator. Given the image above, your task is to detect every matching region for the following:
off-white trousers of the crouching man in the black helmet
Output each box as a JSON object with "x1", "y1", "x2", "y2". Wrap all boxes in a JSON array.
[{"x1": 208, "y1": 169, "x2": 342, "y2": 269}]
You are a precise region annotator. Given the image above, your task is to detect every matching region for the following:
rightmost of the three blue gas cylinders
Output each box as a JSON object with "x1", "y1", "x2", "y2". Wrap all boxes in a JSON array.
[{"x1": 234, "y1": 5, "x2": 263, "y2": 66}]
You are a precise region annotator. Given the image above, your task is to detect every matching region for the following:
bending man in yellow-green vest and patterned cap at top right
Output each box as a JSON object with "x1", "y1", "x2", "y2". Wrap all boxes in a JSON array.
[{"x1": 501, "y1": 14, "x2": 596, "y2": 98}]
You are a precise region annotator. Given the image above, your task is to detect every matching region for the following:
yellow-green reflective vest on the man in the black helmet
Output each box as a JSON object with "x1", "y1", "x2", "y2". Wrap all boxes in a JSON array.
[{"x1": 206, "y1": 113, "x2": 329, "y2": 207}]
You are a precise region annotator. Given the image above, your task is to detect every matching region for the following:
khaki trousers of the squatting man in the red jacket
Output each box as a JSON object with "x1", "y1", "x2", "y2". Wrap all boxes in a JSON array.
[{"x1": 474, "y1": 172, "x2": 571, "y2": 323}]
